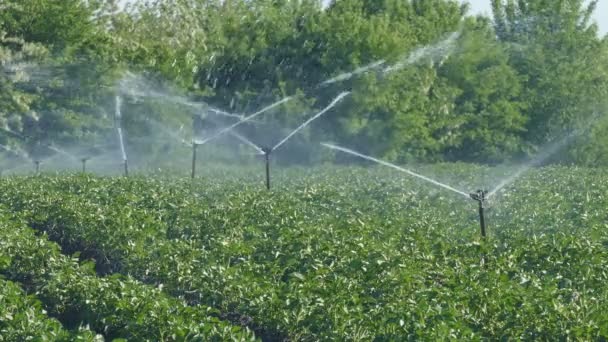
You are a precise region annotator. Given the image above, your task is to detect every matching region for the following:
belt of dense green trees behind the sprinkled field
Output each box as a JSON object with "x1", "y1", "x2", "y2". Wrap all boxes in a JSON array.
[{"x1": 0, "y1": 0, "x2": 608, "y2": 165}]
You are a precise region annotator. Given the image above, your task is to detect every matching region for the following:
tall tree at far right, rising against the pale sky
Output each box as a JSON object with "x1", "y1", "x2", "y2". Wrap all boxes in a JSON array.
[{"x1": 492, "y1": 0, "x2": 608, "y2": 144}]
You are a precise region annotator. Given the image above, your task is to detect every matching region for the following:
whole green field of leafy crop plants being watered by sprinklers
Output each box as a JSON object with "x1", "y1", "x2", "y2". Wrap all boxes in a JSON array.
[{"x1": 0, "y1": 165, "x2": 608, "y2": 341}]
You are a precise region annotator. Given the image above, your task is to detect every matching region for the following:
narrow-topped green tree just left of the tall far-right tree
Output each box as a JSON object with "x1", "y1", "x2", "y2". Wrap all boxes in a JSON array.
[{"x1": 435, "y1": 18, "x2": 528, "y2": 163}]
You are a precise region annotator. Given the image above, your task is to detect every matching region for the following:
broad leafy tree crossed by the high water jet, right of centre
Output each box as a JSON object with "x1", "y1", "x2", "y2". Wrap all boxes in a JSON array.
[{"x1": 322, "y1": 0, "x2": 465, "y2": 161}]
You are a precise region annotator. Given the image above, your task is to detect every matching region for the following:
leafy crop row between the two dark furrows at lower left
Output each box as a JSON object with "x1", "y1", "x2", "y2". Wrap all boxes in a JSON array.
[{"x1": 0, "y1": 210, "x2": 253, "y2": 341}]
